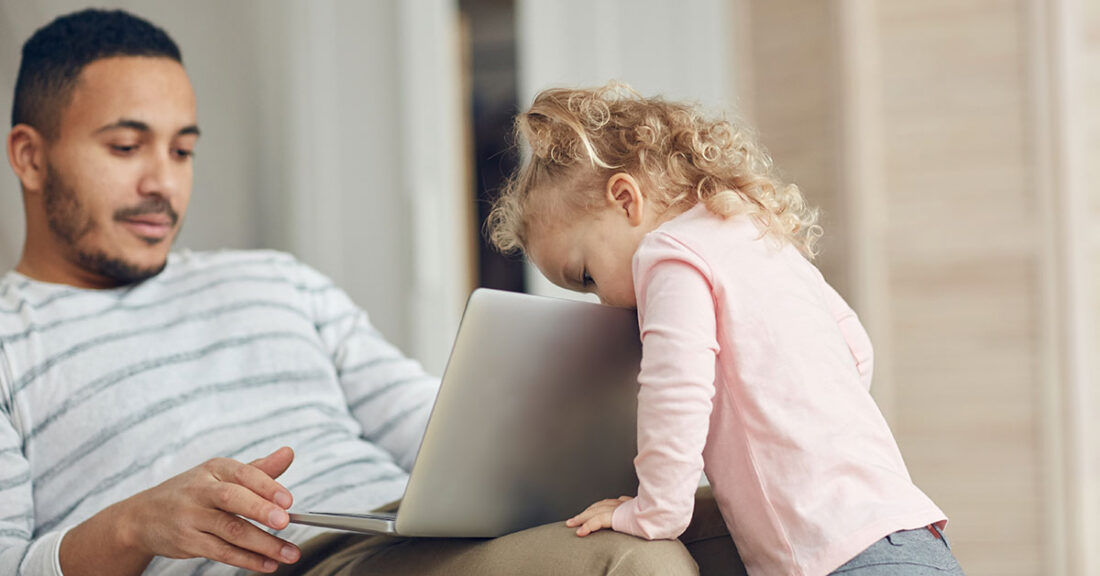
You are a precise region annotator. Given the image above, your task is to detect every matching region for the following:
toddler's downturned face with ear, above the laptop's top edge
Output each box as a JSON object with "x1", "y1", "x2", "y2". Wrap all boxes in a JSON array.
[{"x1": 526, "y1": 174, "x2": 657, "y2": 308}]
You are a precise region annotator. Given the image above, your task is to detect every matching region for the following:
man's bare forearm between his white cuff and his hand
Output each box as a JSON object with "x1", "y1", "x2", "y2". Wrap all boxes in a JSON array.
[{"x1": 59, "y1": 502, "x2": 153, "y2": 576}]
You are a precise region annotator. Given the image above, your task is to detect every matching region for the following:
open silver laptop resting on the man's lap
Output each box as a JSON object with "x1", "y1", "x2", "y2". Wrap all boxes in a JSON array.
[{"x1": 290, "y1": 289, "x2": 641, "y2": 538}]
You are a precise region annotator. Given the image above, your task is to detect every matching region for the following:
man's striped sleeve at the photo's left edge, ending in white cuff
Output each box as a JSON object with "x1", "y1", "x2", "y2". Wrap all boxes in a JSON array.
[{"x1": 0, "y1": 348, "x2": 64, "y2": 576}]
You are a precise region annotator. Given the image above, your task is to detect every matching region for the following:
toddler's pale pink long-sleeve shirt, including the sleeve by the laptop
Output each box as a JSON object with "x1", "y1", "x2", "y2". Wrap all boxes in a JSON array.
[{"x1": 612, "y1": 204, "x2": 946, "y2": 575}]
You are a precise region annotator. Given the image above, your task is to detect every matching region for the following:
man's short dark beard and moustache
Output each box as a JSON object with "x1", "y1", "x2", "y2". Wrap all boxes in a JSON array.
[{"x1": 43, "y1": 166, "x2": 179, "y2": 285}]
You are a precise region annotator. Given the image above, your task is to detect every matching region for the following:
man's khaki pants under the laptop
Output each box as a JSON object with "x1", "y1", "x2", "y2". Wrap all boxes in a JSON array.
[{"x1": 265, "y1": 487, "x2": 745, "y2": 576}]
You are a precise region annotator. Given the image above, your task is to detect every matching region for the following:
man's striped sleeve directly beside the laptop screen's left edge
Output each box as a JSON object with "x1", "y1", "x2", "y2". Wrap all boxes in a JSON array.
[{"x1": 306, "y1": 260, "x2": 439, "y2": 472}]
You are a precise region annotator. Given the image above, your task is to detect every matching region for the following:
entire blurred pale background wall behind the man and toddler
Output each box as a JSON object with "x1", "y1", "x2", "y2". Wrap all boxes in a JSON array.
[{"x1": 0, "y1": 0, "x2": 1100, "y2": 576}]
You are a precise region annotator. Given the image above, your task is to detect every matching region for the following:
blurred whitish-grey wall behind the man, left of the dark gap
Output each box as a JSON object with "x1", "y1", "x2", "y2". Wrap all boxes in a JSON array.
[{"x1": 0, "y1": 0, "x2": 473, "y2": 373}]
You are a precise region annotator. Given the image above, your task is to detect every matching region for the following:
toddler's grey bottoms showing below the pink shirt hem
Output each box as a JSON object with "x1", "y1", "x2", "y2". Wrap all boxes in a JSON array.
[{"x1": 833, "y1": 528, "x2": 964, "y2": 576}]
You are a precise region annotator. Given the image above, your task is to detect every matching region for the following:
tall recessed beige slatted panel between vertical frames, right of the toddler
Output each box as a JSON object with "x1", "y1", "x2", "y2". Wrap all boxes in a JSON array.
[{"x1": 876, "y1": 0, "x2": 1044, "y2": 576}]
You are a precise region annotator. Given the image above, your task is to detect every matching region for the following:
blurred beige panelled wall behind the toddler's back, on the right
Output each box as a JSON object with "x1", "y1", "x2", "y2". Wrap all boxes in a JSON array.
[{"x1": 739, "y1": 0, "x2": 1100, "y2": 576}]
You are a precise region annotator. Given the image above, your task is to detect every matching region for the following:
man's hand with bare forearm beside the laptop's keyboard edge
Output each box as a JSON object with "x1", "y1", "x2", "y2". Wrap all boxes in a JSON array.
[{"x1": 61, "y1": 447, "x2": 300, "y2": 575}]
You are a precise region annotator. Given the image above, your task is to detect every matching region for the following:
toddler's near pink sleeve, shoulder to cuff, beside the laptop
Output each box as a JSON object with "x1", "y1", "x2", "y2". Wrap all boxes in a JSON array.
[{"x1": 612, "y1": 236, "x2": 718, "y2": 540}]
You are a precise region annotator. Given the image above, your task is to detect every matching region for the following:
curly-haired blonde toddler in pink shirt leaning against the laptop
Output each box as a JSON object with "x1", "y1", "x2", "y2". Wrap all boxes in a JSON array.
[{"x1": 487, "y1": 84, "x2": 961, "y2": 575}]
